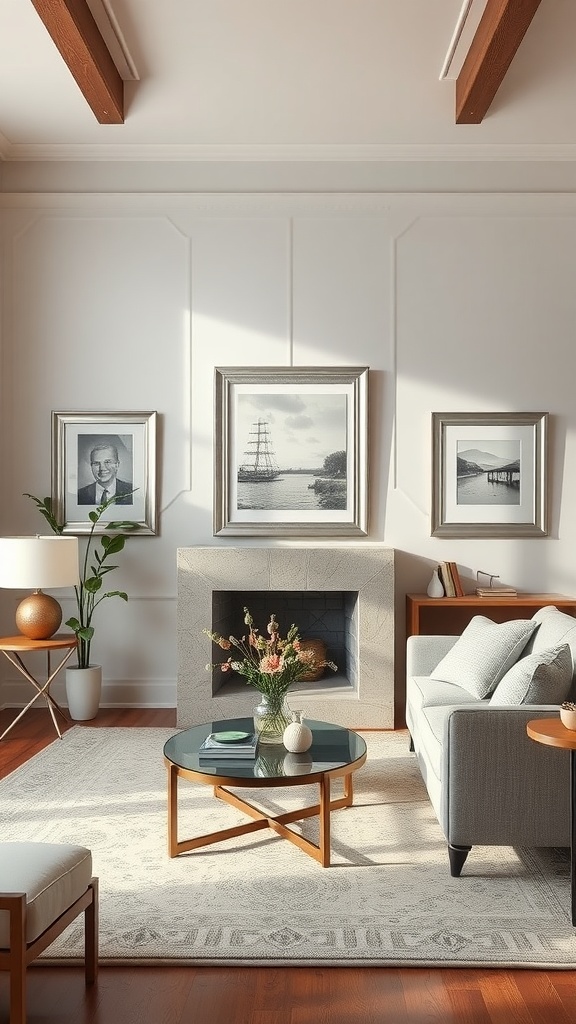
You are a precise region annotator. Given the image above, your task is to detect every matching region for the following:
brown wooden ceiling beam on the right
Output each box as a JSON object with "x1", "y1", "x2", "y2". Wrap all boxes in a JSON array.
[{"x1": 456, "y1": 0, "x2": 541, "y2": 125}]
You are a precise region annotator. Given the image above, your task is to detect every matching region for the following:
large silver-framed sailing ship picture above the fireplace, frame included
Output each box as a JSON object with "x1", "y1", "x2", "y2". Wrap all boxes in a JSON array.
[{"x1": 213, "y1": 367, "x2": 368, "y2": 537}]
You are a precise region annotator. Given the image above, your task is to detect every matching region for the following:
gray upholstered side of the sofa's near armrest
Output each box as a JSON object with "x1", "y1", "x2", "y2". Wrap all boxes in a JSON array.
[{"x1": 441, "y1": 705, "x2": 570, "y2": 847}]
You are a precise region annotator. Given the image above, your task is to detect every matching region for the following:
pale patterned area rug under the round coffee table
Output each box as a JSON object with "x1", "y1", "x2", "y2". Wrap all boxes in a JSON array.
[{"x1": 0, "y1": 727, "x2": 576, "y2": 969}]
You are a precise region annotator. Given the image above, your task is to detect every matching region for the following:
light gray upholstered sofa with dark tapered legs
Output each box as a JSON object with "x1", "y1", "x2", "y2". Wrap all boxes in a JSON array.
[{"x1": 406, "y1": 607, "x2": 576, "y2": 877}]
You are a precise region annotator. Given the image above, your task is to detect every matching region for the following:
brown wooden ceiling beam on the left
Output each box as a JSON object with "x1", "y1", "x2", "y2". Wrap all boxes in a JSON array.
[{"x1": 32, "y1": 0, "x2": 124, "y2": 125}]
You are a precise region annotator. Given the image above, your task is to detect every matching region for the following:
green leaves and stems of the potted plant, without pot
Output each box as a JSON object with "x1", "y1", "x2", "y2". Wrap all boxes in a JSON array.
[{"x1": 25, "y1": 494, "x2": 138, "y2": 669}]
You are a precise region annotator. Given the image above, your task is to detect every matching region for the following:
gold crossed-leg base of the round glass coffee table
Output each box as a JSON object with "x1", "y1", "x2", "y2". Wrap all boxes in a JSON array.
[{"x1": 165, "y1": 759, "x2": 359, "y2": 867}]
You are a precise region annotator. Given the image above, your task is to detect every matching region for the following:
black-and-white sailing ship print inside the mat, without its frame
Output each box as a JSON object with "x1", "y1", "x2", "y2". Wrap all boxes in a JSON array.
[{"x1": 236, "y1": 391, "x2": 348, "y2": 511}]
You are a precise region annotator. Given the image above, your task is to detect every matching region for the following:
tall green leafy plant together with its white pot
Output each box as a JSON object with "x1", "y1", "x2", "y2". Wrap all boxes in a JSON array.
[{"x1": 25, "y1": 494, "x2": 138, "y2": 721}]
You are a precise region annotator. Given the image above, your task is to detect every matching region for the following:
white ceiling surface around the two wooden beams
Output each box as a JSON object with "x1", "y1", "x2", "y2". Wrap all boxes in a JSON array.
[{"x1": 0, "y1": 0, "x2": 576, "y2": 160}]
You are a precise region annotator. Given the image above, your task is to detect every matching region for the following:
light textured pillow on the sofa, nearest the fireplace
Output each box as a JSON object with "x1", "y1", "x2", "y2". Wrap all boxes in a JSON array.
[{"x1": 430, "y1": 615, "x2": 537, "y2": 698}]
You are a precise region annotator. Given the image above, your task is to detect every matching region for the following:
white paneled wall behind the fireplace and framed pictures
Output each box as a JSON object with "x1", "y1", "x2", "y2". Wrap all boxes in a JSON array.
[{"x1": 0, "y1": 194, "x2": 576, "y2": 706}]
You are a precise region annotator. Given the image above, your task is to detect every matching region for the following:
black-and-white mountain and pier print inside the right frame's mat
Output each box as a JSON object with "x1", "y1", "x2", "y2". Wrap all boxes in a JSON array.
[{"x1": 456, "y1": 439, "x2": 521, "y2": 505}]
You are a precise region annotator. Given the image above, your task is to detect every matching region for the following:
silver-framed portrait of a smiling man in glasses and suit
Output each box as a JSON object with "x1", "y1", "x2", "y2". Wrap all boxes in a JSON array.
[{"x1": 52, "y1": 412, "x2": 157, "y2": 536}]
